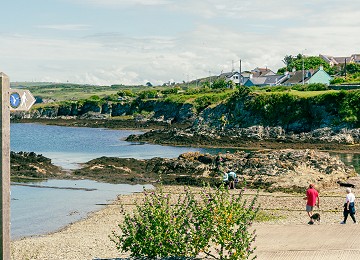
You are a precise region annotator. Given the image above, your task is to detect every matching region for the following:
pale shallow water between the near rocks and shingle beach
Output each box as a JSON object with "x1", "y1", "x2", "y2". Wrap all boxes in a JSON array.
[{"x1": 10, "y1": 180, "x2": 153, "y2": 239}]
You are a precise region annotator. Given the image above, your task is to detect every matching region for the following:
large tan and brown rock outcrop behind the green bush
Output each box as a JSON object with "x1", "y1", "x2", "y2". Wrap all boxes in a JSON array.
[{"x1": 75, "y1": 149, "x2": 356, "y2": 191}]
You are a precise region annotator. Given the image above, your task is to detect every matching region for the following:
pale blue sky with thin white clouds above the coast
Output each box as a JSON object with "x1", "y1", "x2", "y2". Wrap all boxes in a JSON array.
[{"x1": 0, "y1": 0, "x2": 360, "y2": 85}]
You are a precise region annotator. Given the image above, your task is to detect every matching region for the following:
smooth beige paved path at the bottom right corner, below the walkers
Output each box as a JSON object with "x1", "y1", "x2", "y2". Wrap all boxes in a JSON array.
[{"x1": 255, "y1": 221, "x2": 360, "y2": 260}]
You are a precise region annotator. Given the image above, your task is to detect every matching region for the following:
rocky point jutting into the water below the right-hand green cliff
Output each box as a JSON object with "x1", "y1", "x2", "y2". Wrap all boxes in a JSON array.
[{"x1": 126, "y1": 126, "x2": 360, "y2": 153}]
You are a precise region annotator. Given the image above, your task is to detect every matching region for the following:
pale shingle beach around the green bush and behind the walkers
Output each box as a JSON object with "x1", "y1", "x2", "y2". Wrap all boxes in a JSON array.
[{"x1": 11, "y1": 186, "x2": 356, "y2": 260}]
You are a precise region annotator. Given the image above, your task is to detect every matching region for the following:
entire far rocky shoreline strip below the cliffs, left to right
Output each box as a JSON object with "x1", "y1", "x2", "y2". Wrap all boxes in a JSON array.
[{"x1": 12, "y1": 117, "x2": 360, "y2": 153}]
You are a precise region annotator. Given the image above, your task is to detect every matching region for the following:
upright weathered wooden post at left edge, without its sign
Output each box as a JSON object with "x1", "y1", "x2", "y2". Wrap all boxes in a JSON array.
[{"x1": 0, "y1": 72, "x2": 10, "y2": 260}]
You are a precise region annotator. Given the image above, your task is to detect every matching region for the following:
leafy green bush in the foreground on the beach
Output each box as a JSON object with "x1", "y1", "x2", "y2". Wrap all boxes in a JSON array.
[{"x1": 110, "y1": 186, "x2": 258, "y2": 260}]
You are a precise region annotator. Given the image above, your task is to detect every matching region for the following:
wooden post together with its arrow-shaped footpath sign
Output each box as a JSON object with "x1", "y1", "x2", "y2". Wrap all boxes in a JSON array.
[{"x1": 0, "y1": 72, "x2": 35, "y2": 260}]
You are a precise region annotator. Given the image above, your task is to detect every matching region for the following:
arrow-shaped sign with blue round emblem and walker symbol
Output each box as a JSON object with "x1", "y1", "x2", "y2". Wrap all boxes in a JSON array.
[{"x1": 10, "y1": 89, "x2": 36, "y2": 111}]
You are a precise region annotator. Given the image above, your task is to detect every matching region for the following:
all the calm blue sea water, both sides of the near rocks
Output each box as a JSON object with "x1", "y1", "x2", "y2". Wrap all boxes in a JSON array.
[{"x1": 11, "y1": 124, "x2": 360, "y2": 239}]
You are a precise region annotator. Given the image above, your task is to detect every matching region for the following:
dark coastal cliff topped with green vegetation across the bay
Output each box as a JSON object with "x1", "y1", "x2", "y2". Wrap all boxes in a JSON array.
[{"x1": 11, "y1": 88, "x2": 360, "y2": 145}]
